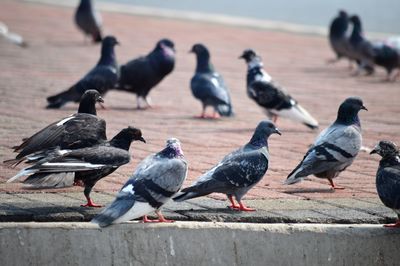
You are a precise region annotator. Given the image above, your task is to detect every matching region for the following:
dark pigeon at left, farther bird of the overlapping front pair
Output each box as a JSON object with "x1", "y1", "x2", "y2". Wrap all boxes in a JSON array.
[{"x1": 5, "y1": 90, "x2": 107, "y2": 166}]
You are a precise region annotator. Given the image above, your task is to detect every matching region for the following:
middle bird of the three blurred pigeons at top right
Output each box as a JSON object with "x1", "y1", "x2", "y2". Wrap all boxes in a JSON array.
[{"x1": 349, "y1": 15, "x2": 375, "y2": 74}]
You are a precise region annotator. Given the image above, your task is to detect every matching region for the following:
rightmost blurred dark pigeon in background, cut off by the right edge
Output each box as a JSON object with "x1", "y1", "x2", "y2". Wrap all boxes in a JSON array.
[{"x1": 373, "y1": 44, "x2": 400, "y2": 81}]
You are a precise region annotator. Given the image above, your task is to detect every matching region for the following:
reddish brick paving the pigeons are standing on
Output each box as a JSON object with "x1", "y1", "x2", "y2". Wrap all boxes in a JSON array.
[{"x1": 0, "y1": 1, "x2": 400, "y2": 223}]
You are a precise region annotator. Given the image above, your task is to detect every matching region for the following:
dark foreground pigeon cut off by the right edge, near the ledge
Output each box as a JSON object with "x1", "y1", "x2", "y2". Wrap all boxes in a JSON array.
[{"x1": 370, "y1": 140, "x2": 400, "y2": 227}]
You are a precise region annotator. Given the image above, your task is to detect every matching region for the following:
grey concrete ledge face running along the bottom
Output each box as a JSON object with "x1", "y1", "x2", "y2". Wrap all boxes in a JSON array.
[{"x1": 0, "y1": 222, "x2": 400, "y2": 265}]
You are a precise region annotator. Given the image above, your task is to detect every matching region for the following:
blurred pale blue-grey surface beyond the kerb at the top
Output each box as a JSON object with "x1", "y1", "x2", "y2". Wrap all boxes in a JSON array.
[{"x1": 97, "y1": 0, "x2": 400, "y2": 34}]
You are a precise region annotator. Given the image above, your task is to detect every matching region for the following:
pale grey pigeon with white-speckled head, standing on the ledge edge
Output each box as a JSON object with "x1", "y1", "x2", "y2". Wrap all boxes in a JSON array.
[{"x1": 92, "y1": 138, "x2": 188, "y2": 227}]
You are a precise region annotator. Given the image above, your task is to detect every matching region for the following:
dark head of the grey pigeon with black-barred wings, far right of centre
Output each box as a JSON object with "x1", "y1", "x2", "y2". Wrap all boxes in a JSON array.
[{"x1": 336, "y1": 97, "x2": 368, "y2": 125}]
